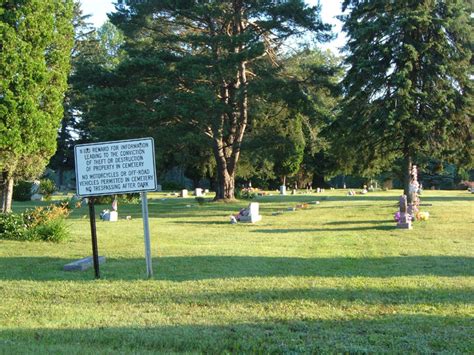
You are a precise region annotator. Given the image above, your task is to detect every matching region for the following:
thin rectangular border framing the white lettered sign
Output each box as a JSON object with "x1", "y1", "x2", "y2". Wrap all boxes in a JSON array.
[{"x1": 74, "y1": 137, "x2": 158, "y2": 197}]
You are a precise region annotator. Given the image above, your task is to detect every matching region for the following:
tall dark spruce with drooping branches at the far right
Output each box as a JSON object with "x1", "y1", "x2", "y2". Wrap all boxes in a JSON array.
[{"x1": 338, "y1": 0, "x2": 474, "y2": 200}]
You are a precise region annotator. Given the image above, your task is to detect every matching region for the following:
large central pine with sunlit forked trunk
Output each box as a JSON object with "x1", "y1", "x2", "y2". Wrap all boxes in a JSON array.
[{"x1": 104, "y1": 0, "x2": 328, "y2": 199}]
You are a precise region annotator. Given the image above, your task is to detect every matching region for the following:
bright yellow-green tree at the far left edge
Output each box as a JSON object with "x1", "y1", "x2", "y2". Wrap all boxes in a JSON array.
[{"x1": 0, "y1": 0, "x2": 73, "y2": 212}]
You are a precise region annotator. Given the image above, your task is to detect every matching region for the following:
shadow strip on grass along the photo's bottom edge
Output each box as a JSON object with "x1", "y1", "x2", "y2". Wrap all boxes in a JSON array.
[{"x1": 0, "y1": 313, "x2": 472, "y2": 353}]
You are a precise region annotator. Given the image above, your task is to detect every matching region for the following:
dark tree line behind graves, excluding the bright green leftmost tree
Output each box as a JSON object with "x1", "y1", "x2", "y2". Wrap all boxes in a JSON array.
[{"x1": 0, "y1": 0, "x2": 473, "y2": 210}]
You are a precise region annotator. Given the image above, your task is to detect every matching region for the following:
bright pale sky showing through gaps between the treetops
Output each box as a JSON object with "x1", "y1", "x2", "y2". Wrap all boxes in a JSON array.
[{"x1": 81, "y1": 0, "x2": 345, "y2": 53}]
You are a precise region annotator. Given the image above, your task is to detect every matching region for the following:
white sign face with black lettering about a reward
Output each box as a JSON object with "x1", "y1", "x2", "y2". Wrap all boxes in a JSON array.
[{"x1": 74, "y1": 138, "x2": 157, "y2": 196}]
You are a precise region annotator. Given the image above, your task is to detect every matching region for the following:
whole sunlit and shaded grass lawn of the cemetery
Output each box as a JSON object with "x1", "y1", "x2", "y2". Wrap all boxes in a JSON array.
[{"x1": 0, "y1": 190, "x2": 474, "y2": 354}]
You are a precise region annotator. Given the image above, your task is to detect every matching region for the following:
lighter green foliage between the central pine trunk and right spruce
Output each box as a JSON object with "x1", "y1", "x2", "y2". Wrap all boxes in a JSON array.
[{"x1": 238, "y1": 49, "x2": 342, "y2": 186}]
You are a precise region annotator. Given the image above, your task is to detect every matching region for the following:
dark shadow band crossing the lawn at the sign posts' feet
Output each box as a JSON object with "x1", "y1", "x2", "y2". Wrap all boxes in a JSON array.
[{"x1": 0, "y1": 255, "x2": 474, "y2": 282}]
